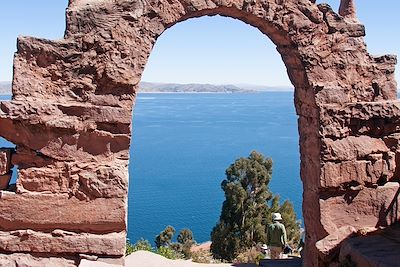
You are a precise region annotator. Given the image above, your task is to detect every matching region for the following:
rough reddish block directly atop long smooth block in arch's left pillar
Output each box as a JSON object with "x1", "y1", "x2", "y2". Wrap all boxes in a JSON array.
[{"x1": 17, "y1": 162, "x2": 128, "y2": 199}]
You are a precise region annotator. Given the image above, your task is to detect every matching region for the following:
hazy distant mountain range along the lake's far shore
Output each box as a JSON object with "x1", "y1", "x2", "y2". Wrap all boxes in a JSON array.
[{"x1": 0, "y1": 82, "x2": 293, "y2": 95}]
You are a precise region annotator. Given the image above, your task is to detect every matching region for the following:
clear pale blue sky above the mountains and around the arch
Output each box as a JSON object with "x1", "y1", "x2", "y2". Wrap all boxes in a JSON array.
[{"x1": 0, "y1": 0, "x2": 400, "y2": 86}]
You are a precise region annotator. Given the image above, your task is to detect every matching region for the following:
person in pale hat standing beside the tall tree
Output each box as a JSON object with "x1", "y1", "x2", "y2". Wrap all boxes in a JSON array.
[{"x1": 267, "y1": 213, "x2": 287, "y2": 259}]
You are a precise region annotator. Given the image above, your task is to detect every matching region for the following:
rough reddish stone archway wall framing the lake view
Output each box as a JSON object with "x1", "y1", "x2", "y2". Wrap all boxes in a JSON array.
[{"x1": 0, "y1": 0, "x2": 400, "y2": 266}]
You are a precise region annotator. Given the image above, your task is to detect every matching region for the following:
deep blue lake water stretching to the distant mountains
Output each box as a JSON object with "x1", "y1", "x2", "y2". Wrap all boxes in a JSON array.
[{"x1": 0, "y1": 92, "x2": 302, "y2": 246}]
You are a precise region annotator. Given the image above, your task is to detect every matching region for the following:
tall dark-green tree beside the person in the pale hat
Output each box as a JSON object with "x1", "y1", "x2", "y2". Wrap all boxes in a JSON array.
[{"x1": 211, "y1": 151, "x2": 299, "y2": 261}]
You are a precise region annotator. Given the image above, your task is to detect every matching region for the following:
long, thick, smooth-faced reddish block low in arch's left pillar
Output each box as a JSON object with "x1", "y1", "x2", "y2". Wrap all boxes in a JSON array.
[{"x1": 0, "y1": 191, "x2": 127, "y2": 233}]
